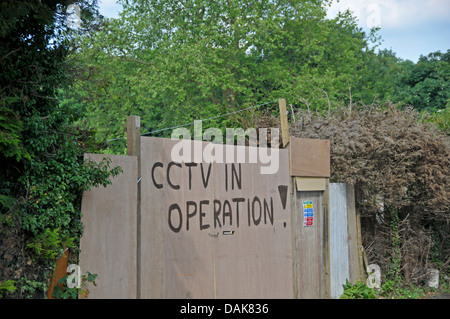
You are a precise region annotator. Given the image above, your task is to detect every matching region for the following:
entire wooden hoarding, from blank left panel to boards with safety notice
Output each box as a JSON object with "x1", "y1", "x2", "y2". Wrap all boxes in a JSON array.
[{"x1": 80, "y1": 124, "x2": 334, "y2": 299}]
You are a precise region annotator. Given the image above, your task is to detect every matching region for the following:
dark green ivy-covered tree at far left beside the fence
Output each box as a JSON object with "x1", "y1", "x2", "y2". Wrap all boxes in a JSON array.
[{"x1": 0, "y1": 0, "x2": 120, "y2": 297}]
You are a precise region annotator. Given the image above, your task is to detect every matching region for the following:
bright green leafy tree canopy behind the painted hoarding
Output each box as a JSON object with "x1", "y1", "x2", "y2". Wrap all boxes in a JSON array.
[{"x1": 65, "y1": 0, "x2": 374, "y2": 152}]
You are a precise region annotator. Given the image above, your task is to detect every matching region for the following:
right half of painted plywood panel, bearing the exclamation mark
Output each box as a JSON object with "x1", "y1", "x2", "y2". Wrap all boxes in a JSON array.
[{"x1": 215, "y1": 150, "x2": 293, "y2": 299}]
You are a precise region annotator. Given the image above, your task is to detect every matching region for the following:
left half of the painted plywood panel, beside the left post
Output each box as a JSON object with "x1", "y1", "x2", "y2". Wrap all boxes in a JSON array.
[{"x1": 141, "y1": 137, "x2": 214, "y2": 298}]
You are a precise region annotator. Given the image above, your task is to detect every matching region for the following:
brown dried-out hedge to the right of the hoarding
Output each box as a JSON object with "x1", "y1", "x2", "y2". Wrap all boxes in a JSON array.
[{"x1": 261, "y1": 104, "x2": 450, "y2": 283}]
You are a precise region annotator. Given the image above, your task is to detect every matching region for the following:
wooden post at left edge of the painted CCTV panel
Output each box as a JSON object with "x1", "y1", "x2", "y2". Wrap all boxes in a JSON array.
[{"x1": 127, "y1": 116, "x2": 141, "y2": 299}]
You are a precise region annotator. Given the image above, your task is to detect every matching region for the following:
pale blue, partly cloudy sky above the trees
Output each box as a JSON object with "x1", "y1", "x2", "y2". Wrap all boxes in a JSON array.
[{"x1": 99, "y1": 0, "x2": 450, "y2": 62}]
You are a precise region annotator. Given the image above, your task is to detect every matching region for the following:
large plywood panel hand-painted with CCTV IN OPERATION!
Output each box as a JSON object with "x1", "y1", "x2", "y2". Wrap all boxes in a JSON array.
[{"x1": 141, "y1": 137, "x2": 294, "y2": 298}]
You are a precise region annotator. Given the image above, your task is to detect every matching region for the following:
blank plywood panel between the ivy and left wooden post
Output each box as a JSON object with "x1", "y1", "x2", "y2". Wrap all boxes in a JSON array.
[{"x1": 80, "y1": 154, "x2": 137, "y2": 299}]
